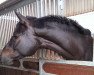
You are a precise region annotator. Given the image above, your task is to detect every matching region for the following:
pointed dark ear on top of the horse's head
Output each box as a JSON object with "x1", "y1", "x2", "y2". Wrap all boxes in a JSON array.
[{"x1": 15, "y1": 11, "x2": 29, "y2": 27}]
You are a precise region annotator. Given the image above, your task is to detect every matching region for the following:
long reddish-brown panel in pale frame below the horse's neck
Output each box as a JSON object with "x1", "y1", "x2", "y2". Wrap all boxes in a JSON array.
[{"x1": 43, "y1": 63, "x2": 94, "y2": 75}]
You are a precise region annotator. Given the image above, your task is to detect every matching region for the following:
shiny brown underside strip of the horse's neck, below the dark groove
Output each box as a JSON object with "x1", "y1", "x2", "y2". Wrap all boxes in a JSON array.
[{"x1": 38, "y1": 37, "x2": 74, "y2": 59}]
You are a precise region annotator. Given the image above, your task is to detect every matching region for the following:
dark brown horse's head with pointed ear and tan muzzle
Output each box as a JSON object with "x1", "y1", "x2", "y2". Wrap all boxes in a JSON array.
[{"x1": 1, "y1": 12, "x2": 38, "y2": 65}]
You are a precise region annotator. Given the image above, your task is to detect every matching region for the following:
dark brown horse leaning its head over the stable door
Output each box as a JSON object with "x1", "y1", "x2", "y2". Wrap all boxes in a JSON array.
[{"x1": 1, "y1": 12, "x2": 93, "y2": 65}]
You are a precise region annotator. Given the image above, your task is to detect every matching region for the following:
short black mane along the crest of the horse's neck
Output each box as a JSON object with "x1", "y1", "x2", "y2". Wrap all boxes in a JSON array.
[{"x1": 35, "y1": 15, "x2": 91, "y2": 36}]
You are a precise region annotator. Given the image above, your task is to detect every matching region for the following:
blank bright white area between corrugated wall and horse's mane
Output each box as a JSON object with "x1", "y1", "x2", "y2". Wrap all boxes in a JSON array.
[{"x1": 69, "y1": 12, "x2": 94, "y2": 34}]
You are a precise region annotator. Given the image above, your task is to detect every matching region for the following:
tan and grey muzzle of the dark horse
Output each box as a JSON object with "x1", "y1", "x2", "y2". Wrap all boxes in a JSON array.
[{"x1": 0, "y1": 47, "x2": 20, "y2": 65}]
